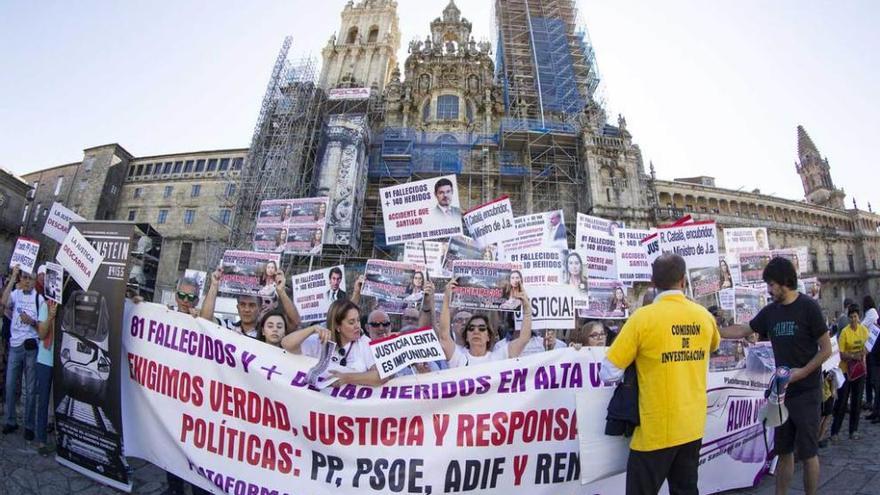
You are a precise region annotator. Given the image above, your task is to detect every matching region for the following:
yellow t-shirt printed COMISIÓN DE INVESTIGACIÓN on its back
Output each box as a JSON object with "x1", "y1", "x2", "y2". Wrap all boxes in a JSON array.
[{"x1": 607, "y1": 293, "x2": 721, "y2": 451}]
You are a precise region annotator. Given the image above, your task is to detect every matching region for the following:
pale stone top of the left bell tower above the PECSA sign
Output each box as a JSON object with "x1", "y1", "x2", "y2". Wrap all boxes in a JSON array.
[{"x1": 320, "y1": 0, "x2": 400, "y2": 94}]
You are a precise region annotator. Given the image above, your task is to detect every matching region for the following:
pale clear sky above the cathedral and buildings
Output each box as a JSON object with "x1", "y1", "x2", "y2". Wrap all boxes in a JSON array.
[{"x1": 0, "y1": 0, "x2": 880, "y2": 210}]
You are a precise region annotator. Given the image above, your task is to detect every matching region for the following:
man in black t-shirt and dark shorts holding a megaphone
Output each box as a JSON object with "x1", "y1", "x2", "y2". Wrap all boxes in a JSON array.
[{"x1": 721, "y1": 258, "x2": 831, "y2": 495}]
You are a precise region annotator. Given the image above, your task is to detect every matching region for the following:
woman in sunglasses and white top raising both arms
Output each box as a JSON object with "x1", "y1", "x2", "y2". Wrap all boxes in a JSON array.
[{"x1": 437, "y1": 279, "x2": 532, "y2": 368}]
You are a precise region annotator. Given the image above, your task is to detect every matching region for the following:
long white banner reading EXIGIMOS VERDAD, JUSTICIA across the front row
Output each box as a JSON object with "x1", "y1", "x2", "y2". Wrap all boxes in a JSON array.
[{"x1": 122, "y1": 303, "x2": 770, "y2": 495}]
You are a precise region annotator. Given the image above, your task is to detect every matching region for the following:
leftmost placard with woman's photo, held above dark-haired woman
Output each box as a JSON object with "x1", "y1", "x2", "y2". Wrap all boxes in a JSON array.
[{"x1": 219, "y1": 250, "x2": 281, "y2": 296}]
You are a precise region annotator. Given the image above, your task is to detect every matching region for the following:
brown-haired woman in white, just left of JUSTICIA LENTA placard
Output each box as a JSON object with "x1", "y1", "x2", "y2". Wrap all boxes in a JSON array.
[{"x1": 281, "y1": 299, "x2": 384, "y2": 387}]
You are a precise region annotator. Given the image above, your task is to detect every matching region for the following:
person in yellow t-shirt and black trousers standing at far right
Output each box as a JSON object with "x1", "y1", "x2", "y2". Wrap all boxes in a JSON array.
[{"x1": 831, "y1": 304, "x2": 868, "y2": 442}]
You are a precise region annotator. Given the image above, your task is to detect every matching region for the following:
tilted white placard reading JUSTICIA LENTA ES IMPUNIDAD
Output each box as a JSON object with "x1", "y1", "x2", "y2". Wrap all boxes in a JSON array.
[{"x1": 370, "y1": 327, "x2": 446, "y2": 378}]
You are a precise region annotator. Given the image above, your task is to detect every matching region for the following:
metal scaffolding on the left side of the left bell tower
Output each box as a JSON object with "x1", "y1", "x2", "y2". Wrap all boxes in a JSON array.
[{"x1": 220, "y1": 36, "x2": 324, "y2": 272}]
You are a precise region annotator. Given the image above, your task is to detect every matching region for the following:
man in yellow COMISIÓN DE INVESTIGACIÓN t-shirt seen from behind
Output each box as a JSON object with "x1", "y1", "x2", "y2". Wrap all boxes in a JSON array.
[{"x1": 601, "y1": 253, "x2": 721, "y2": 495}]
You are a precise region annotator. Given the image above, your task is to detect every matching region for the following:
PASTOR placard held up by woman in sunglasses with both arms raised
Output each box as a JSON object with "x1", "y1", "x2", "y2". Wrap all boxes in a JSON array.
[{"x1": 452, "y1": 260, "x2": 522, "y2": 311}]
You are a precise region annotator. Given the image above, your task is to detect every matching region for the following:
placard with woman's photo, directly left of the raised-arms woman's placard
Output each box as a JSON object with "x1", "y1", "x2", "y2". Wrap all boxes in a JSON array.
[{"x1": 361, "y1": 260, "x2": 425, "y2": 314}]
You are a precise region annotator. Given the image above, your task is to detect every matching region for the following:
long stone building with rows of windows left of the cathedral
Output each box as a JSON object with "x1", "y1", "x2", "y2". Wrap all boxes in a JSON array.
[{"x1": 23, "y1": 144, "x2": 247, "y2": 300}]
